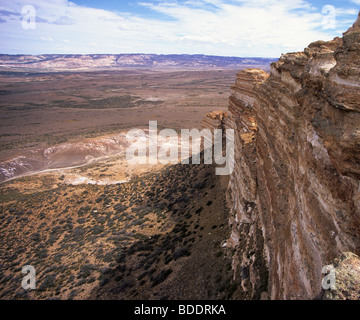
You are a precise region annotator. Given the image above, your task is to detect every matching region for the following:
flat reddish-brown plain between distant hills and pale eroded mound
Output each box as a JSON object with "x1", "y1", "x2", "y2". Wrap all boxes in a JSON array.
[{"x1": 0, "y1": 70, "x2": 236, "y2": 160}]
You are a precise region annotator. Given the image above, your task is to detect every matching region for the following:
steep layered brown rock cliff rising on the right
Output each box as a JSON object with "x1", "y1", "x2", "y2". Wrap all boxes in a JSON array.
[{"x1": 203, "y1": 11, "x2": 360, "y2": 299}]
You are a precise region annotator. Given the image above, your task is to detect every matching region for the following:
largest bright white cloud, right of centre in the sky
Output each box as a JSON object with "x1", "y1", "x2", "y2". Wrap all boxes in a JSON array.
[{"x1": 136, "y1": 0, "x2": 324, "y2": 49}]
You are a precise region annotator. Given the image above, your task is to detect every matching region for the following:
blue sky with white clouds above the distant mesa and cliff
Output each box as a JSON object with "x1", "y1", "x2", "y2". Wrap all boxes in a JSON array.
[{"x1": 0, "y1": 0, "x2": 360, "y2": 58}]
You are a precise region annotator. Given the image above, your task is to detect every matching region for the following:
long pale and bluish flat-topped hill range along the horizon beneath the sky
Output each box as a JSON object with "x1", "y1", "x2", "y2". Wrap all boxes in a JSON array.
[{"x1": 0, "y1": 54, "x2": 276, "y2": 72}]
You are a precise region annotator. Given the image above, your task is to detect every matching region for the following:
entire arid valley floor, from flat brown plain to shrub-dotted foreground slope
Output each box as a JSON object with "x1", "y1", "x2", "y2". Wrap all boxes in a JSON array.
[{"x1": 0, "y1": 66, "x2": 266, "y2": 299}]
